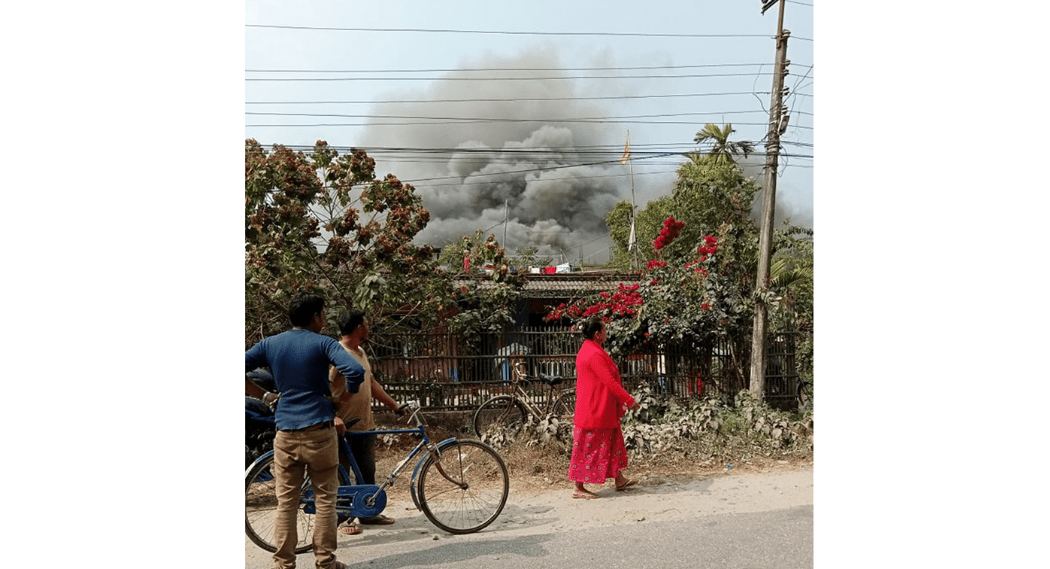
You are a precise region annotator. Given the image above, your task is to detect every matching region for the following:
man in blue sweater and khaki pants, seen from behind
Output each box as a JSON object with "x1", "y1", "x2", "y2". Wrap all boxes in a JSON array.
[{"x1": 245, "y1": 293, "x2": 364, "y2": 569}]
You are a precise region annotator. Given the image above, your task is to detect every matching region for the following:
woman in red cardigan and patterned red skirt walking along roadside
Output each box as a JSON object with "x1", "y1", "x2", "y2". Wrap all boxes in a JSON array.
[{"x1": 569, "y1": 316, "x2": 638, "y2": 500}]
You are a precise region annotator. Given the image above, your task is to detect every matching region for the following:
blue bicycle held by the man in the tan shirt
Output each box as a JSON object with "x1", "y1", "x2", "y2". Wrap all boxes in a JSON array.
[{"x1": 245, "y1": 403, "x2": 510, "y2": 553}]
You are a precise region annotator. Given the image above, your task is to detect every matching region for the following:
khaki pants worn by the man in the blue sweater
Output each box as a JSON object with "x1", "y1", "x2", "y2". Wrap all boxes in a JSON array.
[{"x1": 273, "y1": 427, "x2": 339, "y2": 569}]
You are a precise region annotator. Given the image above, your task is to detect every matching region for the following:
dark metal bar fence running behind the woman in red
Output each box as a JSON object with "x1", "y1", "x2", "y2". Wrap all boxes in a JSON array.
[{"x1": 368, "y1": 326, "x2": 799, "y2": 410}]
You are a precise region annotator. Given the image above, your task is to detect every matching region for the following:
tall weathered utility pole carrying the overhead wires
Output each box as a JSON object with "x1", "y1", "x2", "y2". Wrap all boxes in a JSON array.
[{"x1": 751, "y1": 0, "x2": 791, "y2": 401}]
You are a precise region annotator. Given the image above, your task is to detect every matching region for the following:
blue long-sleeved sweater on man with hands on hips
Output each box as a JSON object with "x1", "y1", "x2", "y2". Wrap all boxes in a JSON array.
[{"x1": 245, "y1": 329, "x2": 364, "y2": 430}]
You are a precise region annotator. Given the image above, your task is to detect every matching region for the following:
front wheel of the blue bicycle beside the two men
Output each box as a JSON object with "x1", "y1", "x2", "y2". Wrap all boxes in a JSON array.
[{"x1": 417, "y1": 440, "x2": 510, "y2": 533}]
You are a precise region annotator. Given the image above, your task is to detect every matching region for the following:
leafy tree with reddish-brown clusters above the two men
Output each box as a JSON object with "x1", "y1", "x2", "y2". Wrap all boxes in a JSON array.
[{"x1": 245, "y1": 140, "x2": 452, "y2": 345}]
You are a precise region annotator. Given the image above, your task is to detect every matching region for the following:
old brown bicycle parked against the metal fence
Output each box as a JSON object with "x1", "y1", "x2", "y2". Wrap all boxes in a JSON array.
[{"x1": 473, "y1": 366, "x2": 576, "y2": 440}]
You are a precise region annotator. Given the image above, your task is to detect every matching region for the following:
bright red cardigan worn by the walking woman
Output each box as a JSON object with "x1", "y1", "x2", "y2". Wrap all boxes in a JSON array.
[{"x1": 573, "y1": 340, "x2": 634, "y2": 428}]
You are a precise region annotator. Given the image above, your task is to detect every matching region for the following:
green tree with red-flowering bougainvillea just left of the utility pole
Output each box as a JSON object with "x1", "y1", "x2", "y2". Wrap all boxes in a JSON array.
[{"x1": 551, "y1": 160, "x2": 759, "y2": 359}]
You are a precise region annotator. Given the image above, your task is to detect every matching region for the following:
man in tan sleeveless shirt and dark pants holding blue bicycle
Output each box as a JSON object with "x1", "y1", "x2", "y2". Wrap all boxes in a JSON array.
[{"x1": 329, "y1": 309, "x2": 403, "y2": 535}]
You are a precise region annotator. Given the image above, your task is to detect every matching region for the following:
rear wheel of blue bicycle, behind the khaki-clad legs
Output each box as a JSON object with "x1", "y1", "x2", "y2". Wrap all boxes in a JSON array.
[{"x1": 245, "y1": 454, "x2": 350, "y2": 553}]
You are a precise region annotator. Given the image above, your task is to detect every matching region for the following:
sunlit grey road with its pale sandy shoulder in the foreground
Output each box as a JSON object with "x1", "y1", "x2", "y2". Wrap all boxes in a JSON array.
[{"x1": 245, "y1": 469, "x2": 814, "y2": 569}]
